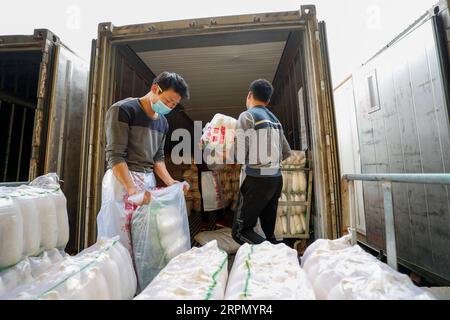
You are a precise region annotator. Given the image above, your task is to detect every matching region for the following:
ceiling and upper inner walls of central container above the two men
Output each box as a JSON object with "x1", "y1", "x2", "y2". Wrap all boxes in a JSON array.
[{"x1": 113, "y1": 29, "x2": 308, "y2": 149}]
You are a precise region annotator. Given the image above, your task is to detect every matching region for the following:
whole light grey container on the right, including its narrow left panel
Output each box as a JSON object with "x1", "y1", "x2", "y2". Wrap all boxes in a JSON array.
[{"x1": 335, "y1": 0, "x2": 450, "y2": 284}]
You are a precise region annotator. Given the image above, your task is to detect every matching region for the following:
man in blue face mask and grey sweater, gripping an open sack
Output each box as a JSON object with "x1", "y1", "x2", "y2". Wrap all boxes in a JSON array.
[{"x1": 97, "y1": 72, "x2": 189, "y2": 251}]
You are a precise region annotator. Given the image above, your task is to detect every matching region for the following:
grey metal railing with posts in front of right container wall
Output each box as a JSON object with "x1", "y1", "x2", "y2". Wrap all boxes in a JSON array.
[{"x1": 343, "y1": 173, "x2": 450, "y2": 270}]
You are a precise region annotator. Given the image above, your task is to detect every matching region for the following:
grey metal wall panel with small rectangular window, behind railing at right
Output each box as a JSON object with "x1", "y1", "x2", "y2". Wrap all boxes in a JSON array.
[{"x1": 354, "y1": 16, "x2": 450, "y2": 280}]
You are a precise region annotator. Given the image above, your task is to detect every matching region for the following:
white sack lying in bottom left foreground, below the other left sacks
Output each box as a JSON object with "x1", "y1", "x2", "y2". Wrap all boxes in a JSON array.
[{"x1": 0, "y1": 238, "x2": 136, "y2": 300}]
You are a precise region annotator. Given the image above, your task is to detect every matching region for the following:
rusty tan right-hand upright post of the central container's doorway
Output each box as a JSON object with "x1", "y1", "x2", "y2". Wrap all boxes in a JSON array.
[{"x1": 301, "y1": 6, "x2": 342, "y2": 239}]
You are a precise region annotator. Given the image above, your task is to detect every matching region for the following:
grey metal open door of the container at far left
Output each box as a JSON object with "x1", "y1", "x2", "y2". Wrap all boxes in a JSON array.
[{"x1": 44, "y1": 43, "x2": 88, "y2": 253}]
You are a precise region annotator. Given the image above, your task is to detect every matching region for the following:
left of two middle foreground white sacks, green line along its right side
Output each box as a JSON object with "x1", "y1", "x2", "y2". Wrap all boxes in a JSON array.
[{"x1": 135, "y1": 241, "x2": 228, "y2": 300}]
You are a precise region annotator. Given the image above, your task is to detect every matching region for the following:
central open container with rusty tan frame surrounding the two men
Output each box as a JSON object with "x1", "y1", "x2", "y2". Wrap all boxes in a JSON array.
[{"x1": 79, "y1": 5, "x2": 341, "y2": 249}]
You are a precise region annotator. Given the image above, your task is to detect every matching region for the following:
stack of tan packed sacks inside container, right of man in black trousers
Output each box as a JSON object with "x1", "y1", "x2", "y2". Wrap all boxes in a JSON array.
[{"x1": 275, "y1": 151, "x2": 308, "y2": 239}]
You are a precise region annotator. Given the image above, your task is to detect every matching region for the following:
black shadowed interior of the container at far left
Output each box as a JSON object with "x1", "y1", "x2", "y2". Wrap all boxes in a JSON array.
[{"x1": 0, "y1": 51, "x2": 42, "y2": 182}]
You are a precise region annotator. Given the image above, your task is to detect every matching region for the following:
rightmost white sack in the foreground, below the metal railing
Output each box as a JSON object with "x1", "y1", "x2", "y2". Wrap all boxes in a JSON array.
[{"x1": 302, "y1": 237, "x2": 434, "y2": 300}]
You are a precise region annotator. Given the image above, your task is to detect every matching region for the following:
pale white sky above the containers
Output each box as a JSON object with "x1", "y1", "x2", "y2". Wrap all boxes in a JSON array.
[{"x1": 0, "y1": 0, "x2": 438, "y2": 86}]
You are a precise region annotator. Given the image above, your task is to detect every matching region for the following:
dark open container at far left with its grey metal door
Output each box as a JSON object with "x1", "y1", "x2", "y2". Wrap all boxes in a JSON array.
[{"x1": 0, "y1": 29, "x2": 89, "y2": 252}]
